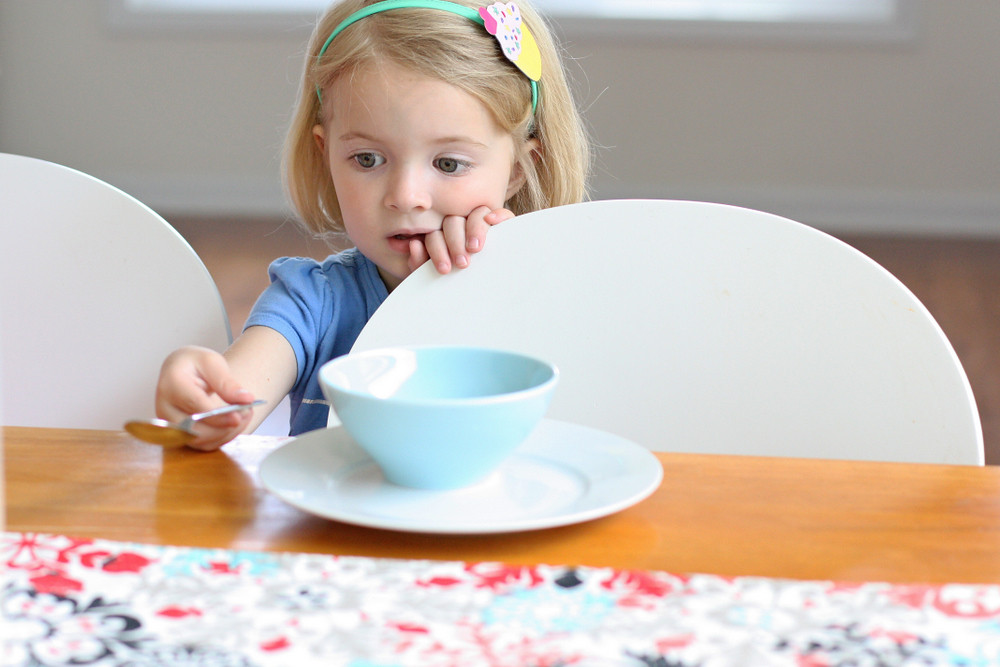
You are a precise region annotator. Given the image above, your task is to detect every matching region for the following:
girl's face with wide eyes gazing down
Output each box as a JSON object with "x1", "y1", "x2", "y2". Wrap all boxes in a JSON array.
[{"x1": 313, "y1": 65, "x2": 524, "y2": 290}]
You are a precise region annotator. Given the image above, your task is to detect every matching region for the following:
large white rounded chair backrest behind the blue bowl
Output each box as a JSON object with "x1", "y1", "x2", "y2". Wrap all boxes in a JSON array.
[{"x1": 350, "y1": 201, "x2": 983, "y2": 464}]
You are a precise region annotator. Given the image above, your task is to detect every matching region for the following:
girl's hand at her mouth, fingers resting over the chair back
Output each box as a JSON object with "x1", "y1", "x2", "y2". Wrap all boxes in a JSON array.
[{"x1": 409, "y1": 206, "x2": 514, "y2": 274}]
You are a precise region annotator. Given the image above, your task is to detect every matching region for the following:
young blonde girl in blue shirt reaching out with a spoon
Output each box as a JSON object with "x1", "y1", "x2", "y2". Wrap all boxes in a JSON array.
[{"x1": 156, "y1": 0, "x2": 589, "y2": 450}]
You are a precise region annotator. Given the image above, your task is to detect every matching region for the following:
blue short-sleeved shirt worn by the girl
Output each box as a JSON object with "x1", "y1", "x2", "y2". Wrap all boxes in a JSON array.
[{"x1": 244, "y1": 248, "x2": 389, "y2": 435}]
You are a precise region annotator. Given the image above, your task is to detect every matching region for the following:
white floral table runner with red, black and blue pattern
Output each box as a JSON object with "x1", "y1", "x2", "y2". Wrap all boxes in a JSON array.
[{"x1": 0, "y1": 533, "x2": 1000, "y2": 667}]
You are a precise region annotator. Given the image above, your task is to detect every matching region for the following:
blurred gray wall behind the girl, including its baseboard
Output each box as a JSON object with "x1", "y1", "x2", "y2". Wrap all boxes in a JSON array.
[{"x1": 0, "y1": 0, "x2": 1000, "y2": 236}]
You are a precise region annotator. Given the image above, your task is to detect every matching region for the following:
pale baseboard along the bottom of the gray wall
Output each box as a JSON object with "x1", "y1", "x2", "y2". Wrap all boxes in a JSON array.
[{"x1": 106, "y1": 173, "x2": 1000, "y2": 238}]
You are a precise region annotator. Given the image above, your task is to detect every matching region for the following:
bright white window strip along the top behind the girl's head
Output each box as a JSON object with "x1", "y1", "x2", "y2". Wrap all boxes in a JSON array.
[{"x1": 107, "y1": 0, "x2": 922, "y2": 43}]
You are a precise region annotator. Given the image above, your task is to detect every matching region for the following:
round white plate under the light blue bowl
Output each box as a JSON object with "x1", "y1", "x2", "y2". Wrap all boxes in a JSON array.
[{"x1": 260, "y1": 419, "x2": 663, "y2": 534}]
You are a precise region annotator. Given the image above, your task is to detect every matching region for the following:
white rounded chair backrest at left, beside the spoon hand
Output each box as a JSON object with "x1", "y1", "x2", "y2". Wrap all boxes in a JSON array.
[{"x1": 0, "y1": 154, "x2": 231, "y2": 429}]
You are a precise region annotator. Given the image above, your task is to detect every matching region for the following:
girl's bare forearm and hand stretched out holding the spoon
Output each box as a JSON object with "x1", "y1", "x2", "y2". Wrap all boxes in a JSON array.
[{"x1": 156, "y1": 327, "x2": 296, "y2": 451}]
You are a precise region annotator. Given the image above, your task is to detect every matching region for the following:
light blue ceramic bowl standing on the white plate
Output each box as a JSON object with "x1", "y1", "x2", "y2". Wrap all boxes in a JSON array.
[{"x1": 319, "y1": 346, "x2": 559, "y2": 489}]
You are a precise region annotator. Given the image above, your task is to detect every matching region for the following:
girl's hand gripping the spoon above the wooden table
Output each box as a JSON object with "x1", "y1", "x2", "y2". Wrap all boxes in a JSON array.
[{"x1": 156, "y1": 346, "x2": 254, "y2": 451}]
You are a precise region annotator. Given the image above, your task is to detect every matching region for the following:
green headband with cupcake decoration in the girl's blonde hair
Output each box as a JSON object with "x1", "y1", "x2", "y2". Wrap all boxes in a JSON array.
[{"x1": 316, "y1": 0, "x2": 542, "y2": 113}]
